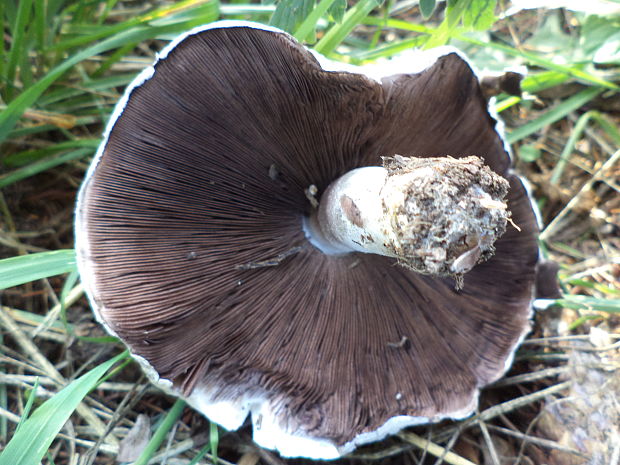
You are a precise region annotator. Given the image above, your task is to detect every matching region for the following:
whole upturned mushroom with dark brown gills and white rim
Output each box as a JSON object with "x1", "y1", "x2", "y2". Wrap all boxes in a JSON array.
[{"x1": 75, "y1": 21, "x2": 538, "y2": 459}]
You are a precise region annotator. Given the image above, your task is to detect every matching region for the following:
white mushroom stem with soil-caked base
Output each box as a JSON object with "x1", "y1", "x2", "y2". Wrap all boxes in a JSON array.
[{"x1": 306, "y1": 155, "x2": 510, "y2": 276}]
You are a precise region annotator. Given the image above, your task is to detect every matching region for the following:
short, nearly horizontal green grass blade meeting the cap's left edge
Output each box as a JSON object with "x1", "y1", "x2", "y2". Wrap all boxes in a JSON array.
[{"x1": 0, "y1": 249, "x2": 76, "y2": 289}]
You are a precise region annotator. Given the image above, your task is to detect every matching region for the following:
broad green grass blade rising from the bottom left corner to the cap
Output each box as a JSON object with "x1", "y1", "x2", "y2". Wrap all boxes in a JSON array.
[{"x1": 0, "y1": 352, "x2": 127, "y2": 465}]
